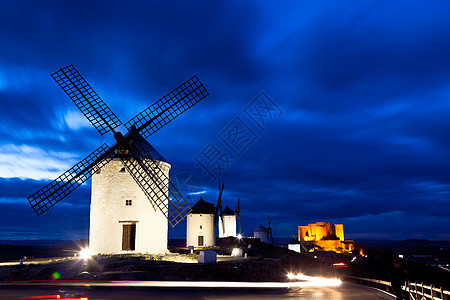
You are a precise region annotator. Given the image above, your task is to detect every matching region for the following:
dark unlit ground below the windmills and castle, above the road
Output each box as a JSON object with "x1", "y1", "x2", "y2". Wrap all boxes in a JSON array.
[{"x1": 0, "y1": 239, "x2": 450, "y2": 289}]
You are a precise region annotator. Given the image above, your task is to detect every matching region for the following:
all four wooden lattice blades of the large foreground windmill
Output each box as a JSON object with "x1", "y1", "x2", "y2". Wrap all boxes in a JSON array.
[{"x1": 28, "y1": 65, "x2": 209, "y2": 227}]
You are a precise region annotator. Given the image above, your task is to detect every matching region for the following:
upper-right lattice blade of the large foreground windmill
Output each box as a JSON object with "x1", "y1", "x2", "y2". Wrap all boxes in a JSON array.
[{"x1": 125, "y1": 76, "x2": 209, "y2": 139}]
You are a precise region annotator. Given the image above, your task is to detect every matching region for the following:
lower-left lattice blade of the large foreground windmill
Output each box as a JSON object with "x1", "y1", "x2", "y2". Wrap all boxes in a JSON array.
[{"x1": 28, "y1": 144, "x2": 113, "y2": 216}]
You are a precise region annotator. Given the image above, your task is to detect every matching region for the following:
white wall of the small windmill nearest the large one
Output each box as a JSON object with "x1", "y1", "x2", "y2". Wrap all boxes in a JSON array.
[{"x1": 186, "y1": 214, "x2": 216, "y2": 247}]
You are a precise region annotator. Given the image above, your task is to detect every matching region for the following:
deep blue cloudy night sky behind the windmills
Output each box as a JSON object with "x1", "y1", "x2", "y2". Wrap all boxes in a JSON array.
[{"x1": 0, "y1": 0, "x2": 450, "y2": 240}]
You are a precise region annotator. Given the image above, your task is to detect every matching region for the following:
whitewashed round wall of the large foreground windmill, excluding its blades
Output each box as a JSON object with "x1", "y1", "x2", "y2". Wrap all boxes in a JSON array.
[{"x1": 89, "y1": 158, "x2": 170, "y2": 253}]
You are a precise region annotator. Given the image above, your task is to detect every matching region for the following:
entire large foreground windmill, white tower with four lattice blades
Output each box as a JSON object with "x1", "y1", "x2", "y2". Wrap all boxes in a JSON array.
[{"x1": 28, "y1": 65, "x2": 208, "y2": 253}]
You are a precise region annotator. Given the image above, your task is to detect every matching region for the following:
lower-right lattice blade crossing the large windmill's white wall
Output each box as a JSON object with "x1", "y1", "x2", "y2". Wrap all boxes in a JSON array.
[{"x1": 122, "y1": 137, "x2": 191, "y2": 227}]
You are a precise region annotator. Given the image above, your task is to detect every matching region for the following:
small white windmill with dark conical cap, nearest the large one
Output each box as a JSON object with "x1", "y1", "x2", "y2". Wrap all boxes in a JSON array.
[{"x1": 186, "y1": 197, "x2": 216, "y2": 247}]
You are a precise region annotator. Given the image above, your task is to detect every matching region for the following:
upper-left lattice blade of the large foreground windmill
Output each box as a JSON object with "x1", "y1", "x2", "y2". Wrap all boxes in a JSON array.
[{"x1": 52, "y1": 65, "x2": 122, "y2": 135}]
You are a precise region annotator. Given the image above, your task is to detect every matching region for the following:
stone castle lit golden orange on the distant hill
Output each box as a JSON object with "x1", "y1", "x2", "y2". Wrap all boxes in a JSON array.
[{"x1": 298, "y1": 222, "x2": 354, "y2": 252}]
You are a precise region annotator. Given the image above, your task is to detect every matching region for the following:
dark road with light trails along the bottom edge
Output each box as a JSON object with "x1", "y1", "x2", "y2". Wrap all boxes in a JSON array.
[{"x1": 0, "y1": 282, "x2": 394, "y2": 300}]
